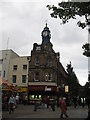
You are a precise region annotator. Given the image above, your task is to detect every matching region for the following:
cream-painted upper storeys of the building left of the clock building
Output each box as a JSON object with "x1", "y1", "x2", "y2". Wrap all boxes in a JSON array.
[{"x1": 0, "y1": 49, "x2": 28, "y2": 87}]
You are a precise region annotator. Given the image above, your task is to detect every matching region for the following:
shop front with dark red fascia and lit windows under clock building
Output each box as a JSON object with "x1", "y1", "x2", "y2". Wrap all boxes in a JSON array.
[{"x1": 28, "y1": 85, "x2": 57, "y2": 103}]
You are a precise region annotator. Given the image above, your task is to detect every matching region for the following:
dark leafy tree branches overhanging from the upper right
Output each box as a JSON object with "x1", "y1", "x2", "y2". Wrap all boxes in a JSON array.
[{"x1": 47, "y1": 1, "x2": 90, "y2": 57}]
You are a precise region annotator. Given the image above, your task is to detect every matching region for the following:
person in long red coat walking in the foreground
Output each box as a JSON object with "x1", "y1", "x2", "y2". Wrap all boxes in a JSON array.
[{"x1": 60, "y1": 97, "x2": 68, "y2": 118}]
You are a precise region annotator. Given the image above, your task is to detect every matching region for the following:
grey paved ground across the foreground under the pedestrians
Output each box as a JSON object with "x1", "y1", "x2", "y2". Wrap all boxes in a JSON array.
[{"x1": 2, "y1": 104, "x2": 88, "y2": 119}]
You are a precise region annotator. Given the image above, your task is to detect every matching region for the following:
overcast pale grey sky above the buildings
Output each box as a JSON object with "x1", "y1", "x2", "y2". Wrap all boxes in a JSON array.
[{"x1": 0, "y1": 0, "x2": 88, "y2": 85}]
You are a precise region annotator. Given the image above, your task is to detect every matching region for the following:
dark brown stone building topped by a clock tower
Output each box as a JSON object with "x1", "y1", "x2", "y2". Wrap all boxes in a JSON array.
[{"x1": 28, "y1": 24, "x2": 67, "y2": 95}]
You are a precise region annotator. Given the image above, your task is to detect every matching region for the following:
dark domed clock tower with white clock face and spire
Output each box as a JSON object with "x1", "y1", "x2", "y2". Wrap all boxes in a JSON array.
[{"x1": 41, "y1": 23, "x2": 51, "y2": 45}]
